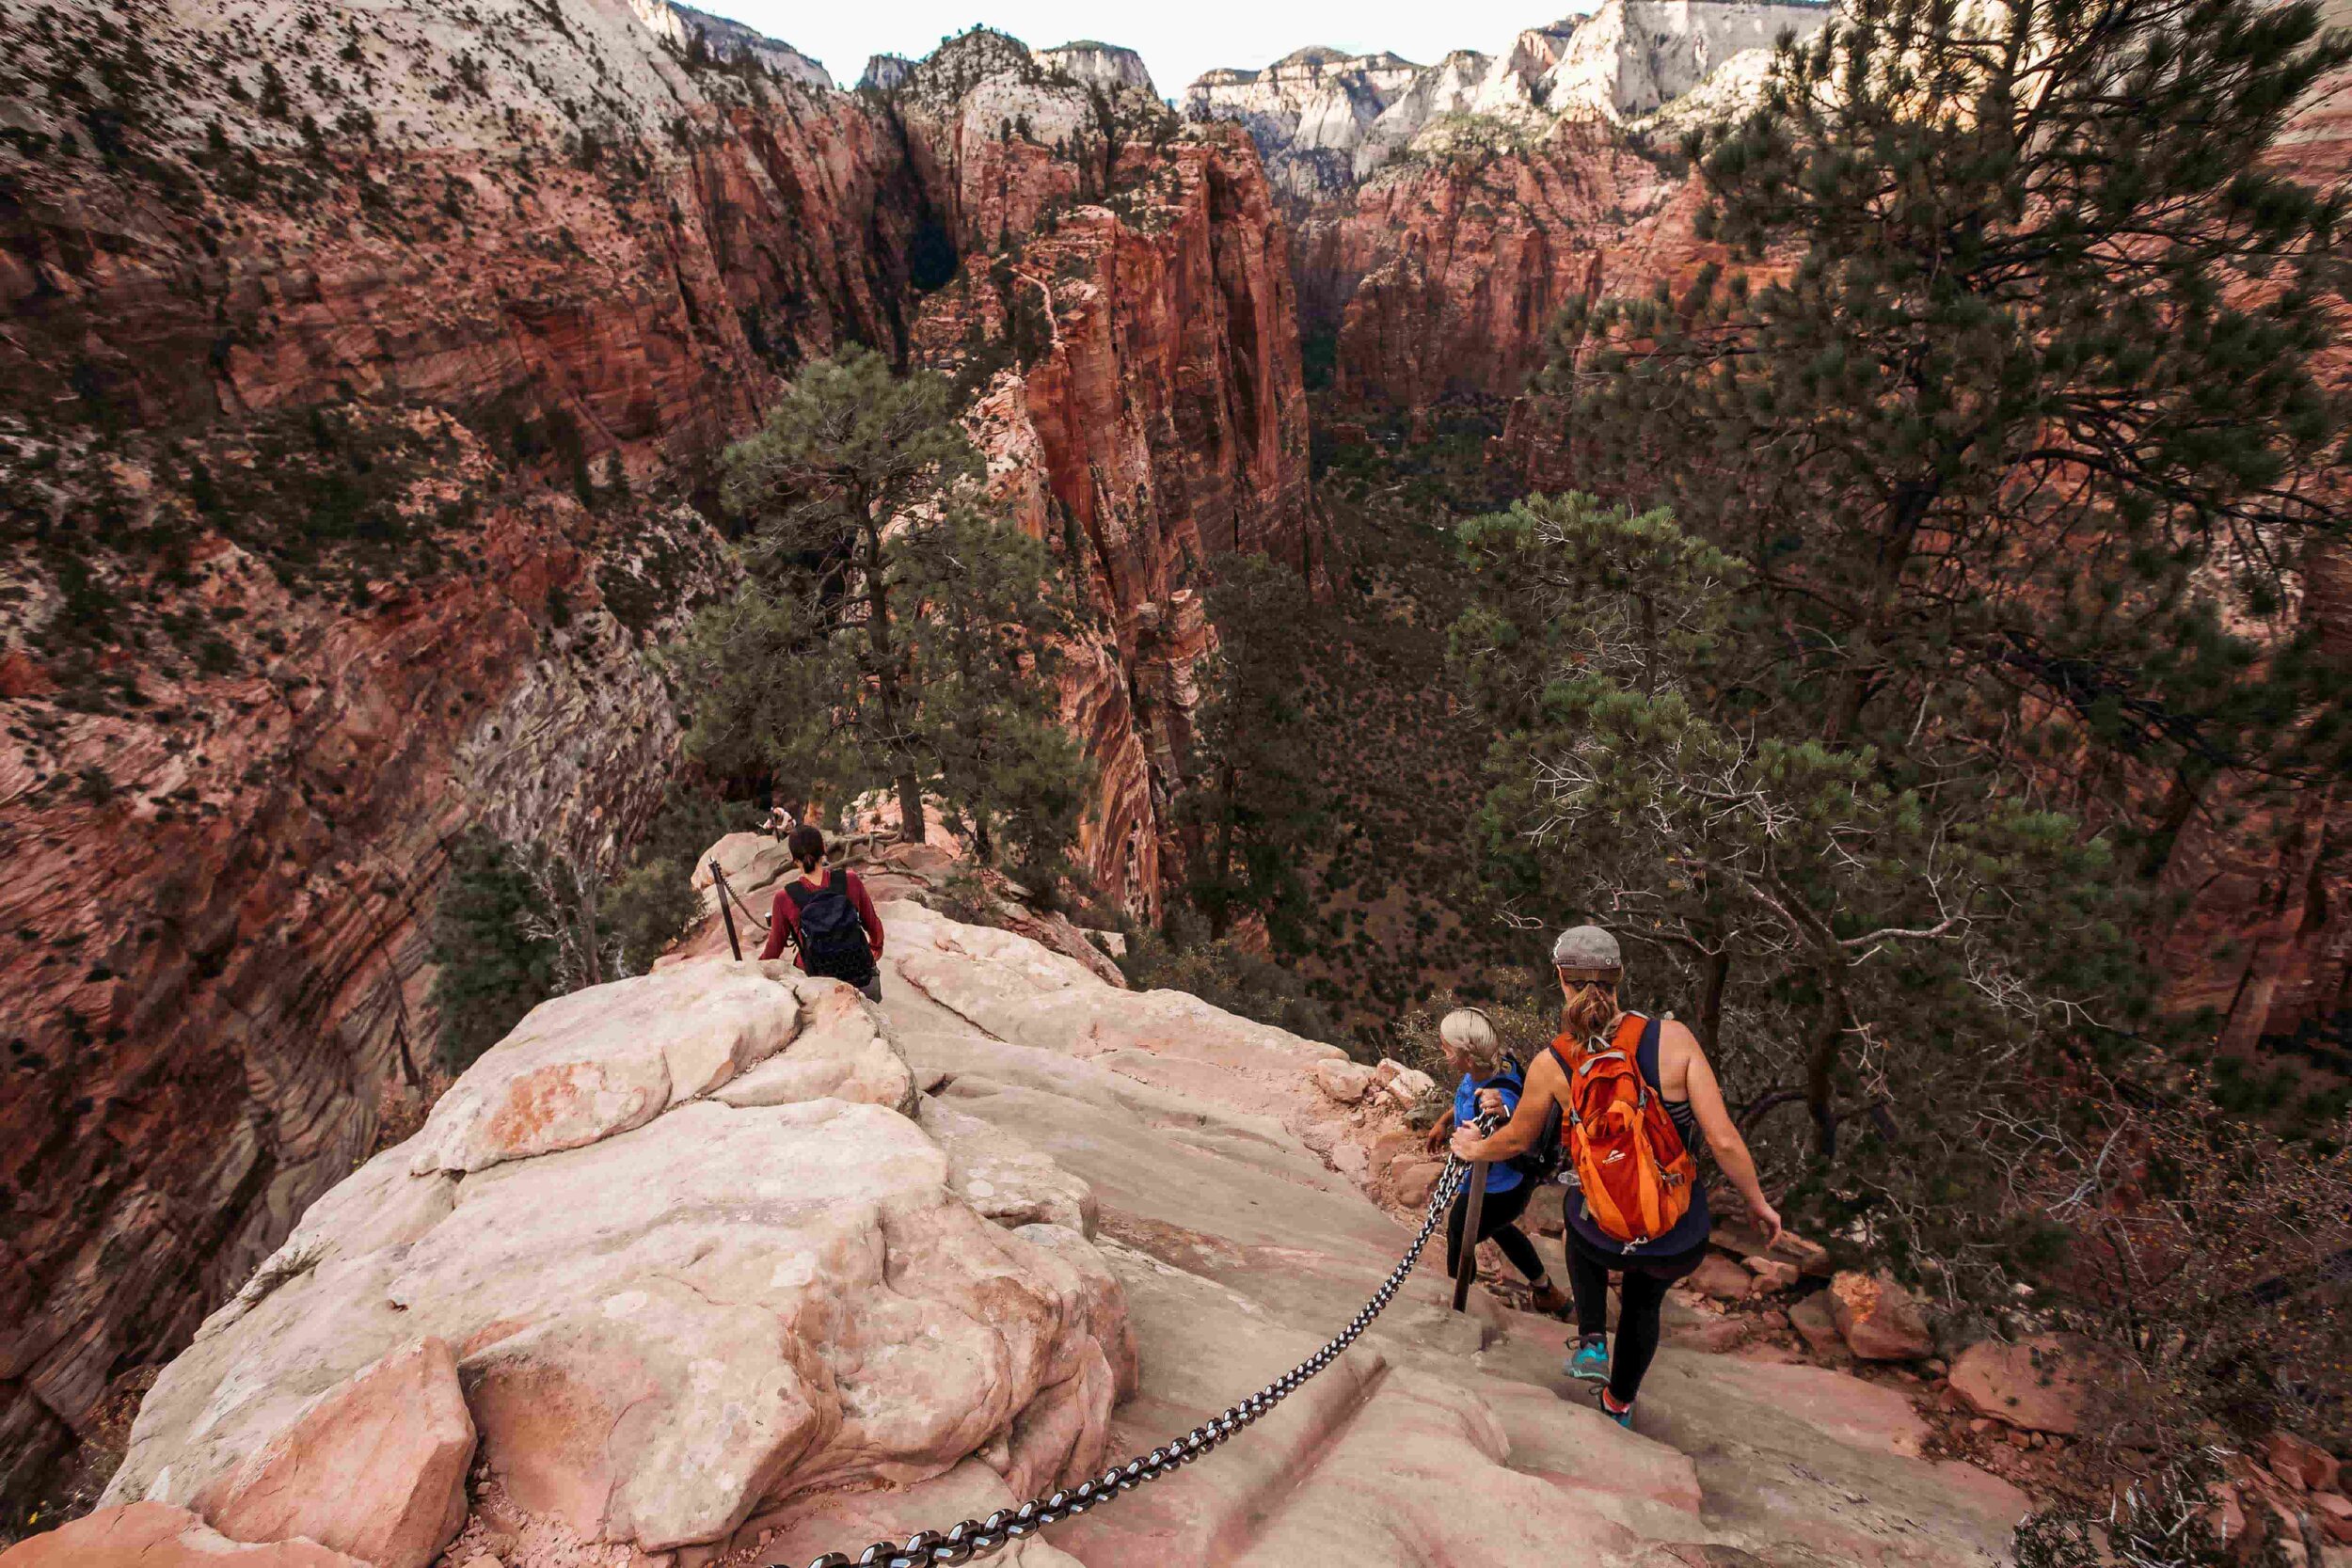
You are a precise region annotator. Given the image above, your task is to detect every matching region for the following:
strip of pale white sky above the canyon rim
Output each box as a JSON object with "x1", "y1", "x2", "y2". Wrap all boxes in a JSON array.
[{"x1": 694, "y1": 0, "x2": 1593, "y2": 99}]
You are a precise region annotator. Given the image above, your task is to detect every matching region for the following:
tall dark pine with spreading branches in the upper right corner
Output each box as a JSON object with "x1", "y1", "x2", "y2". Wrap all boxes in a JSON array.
[{"x1": 1548, "y1": 0, "x2": 2352, "y2": 804}]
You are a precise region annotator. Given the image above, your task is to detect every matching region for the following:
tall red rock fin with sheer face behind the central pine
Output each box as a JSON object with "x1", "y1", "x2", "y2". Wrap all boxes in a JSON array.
[{"x1": 894, "y1": 46, "x2": 1322, "y2": 914}]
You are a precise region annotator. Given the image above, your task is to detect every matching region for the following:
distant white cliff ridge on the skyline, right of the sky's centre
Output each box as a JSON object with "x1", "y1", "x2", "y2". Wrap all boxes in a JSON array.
[{"x1": 1184, "y1": 0, "x2": 1830, "y2": 199}]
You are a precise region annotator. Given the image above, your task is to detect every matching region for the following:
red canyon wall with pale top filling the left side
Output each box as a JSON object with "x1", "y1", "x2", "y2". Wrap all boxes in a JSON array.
[{"x1": 0, "y1": 0, "x2": 920, "y2": 1491}]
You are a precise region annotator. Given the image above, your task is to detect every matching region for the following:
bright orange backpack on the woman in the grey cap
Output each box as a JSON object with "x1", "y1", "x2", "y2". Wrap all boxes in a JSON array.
[{"x1": 1552, "y1": 1013, "x2": 1698, "y2": 1246}]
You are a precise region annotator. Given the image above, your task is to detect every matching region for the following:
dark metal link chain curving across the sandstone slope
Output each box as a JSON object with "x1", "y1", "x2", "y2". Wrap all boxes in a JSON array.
[{"x1": 770, "y1": 1132, "x2": 1494, "y2": 1568}]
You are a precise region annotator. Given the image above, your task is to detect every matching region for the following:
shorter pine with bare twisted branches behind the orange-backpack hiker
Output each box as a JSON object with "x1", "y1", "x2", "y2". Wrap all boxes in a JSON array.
[{"x1": 1454, "y1": 496, "x2": 2129, "y2": 1154}]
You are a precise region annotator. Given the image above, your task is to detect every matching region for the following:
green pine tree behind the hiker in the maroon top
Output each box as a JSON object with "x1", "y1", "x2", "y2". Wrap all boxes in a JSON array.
[{"x1": 671, "y1": 350, "x2": 1089, "y2": 875}]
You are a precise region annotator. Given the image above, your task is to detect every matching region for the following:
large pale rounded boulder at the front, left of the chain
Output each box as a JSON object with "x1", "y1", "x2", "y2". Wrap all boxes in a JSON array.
[{"x1": 113, "y1": 1062, "x2": 1134, "y2": 1552}]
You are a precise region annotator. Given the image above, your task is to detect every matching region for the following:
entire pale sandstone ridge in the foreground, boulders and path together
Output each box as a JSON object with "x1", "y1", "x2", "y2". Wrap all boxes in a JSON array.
[{"x1": 55, "y1": 888, "x2": 2023, "y2": 1568}]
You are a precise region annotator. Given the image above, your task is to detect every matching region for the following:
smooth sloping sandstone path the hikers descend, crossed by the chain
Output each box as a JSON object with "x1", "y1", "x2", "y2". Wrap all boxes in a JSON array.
[{"x1": 809, "y1": 905, "x2": 2026, "y2": 1568}]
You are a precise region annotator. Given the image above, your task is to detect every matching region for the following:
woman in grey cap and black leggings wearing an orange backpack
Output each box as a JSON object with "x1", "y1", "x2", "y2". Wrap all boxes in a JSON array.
[{"x1": 1454, "y1": 927, "x2": 1781, "y2": 1427}]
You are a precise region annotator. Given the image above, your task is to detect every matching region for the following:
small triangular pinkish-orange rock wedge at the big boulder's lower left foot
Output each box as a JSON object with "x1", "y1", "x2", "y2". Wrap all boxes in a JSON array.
[{"x1": 196, "y1": 1340, "x2": 473, "y2": 1568}]
